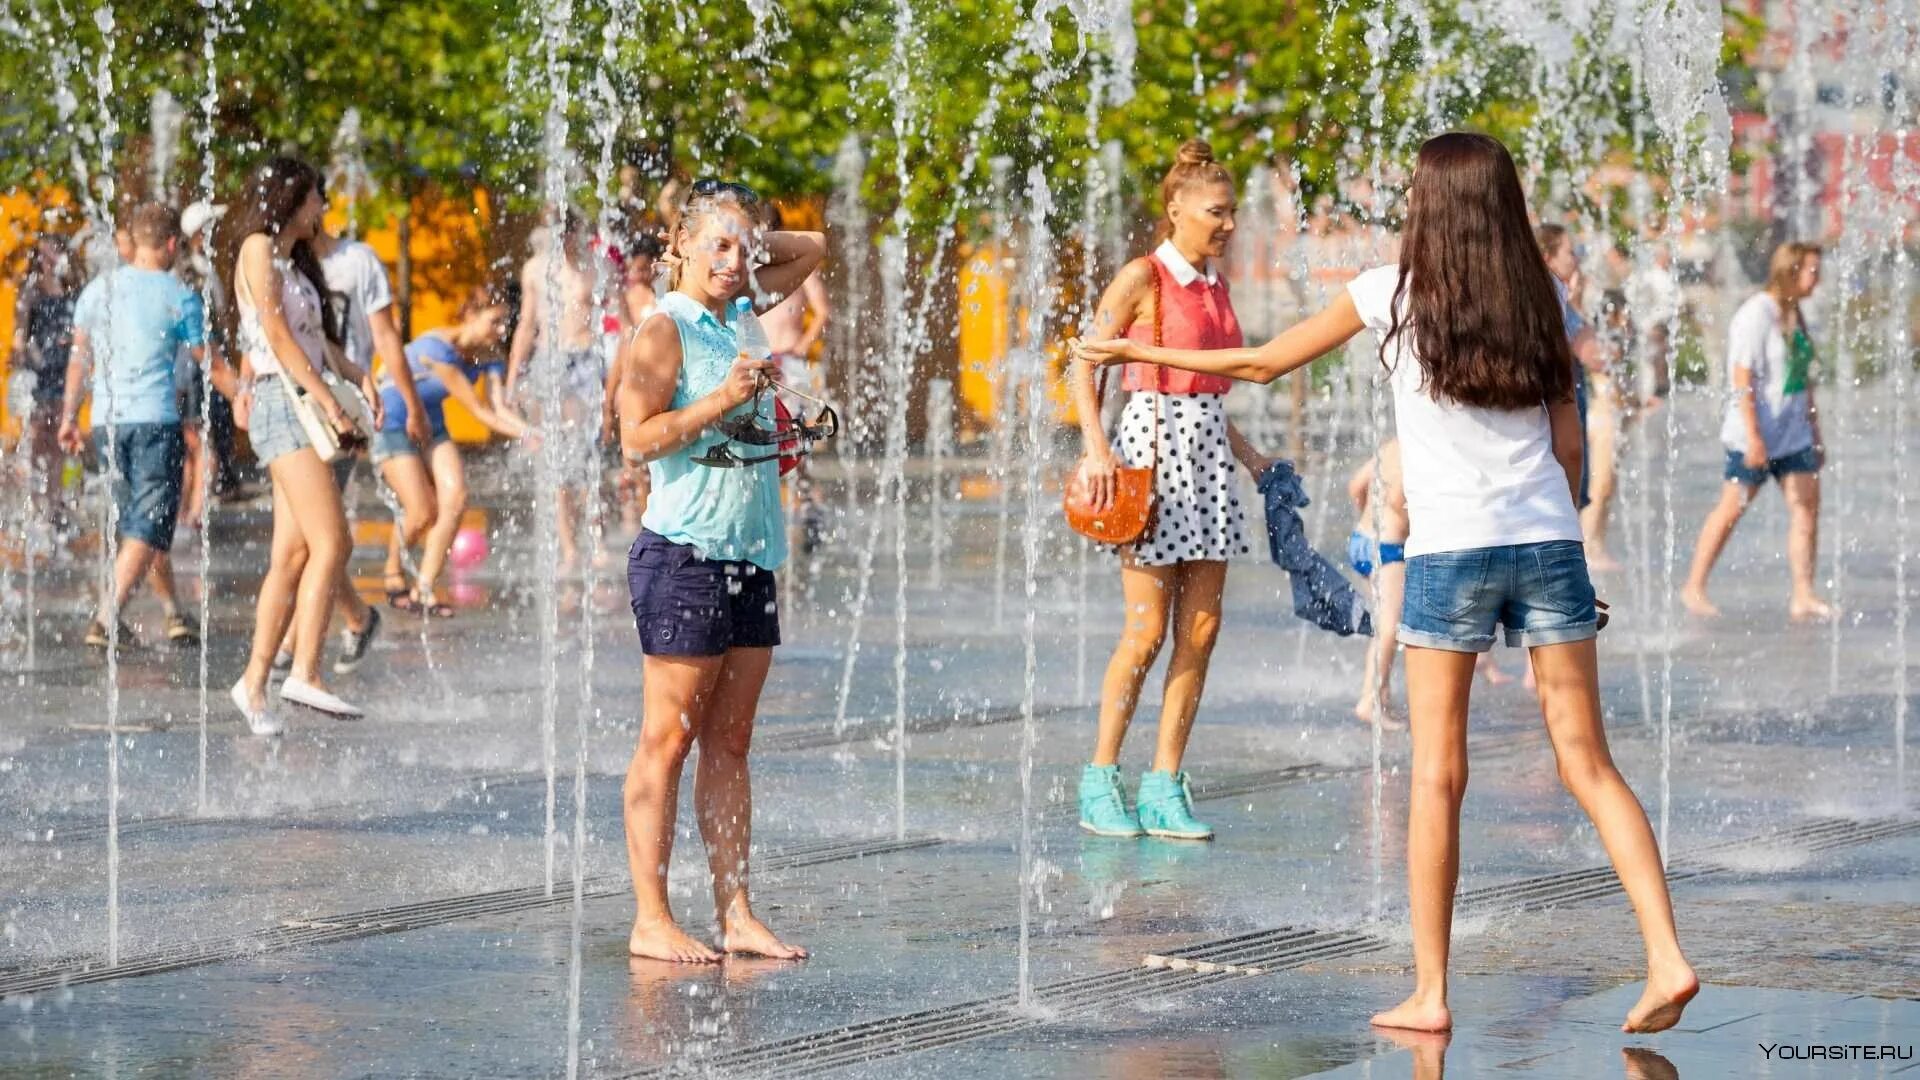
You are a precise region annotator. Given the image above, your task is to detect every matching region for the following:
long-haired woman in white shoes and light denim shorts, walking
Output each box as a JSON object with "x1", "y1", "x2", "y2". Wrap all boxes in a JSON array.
[{"x1": 221, "y1": 158, "x2": 372, "y2": 734}]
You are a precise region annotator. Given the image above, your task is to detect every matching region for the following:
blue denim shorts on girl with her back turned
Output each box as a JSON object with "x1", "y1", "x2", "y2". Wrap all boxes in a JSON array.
[{"x1": 1400, "y1": 540, "x2": 1599, "y2": 653}]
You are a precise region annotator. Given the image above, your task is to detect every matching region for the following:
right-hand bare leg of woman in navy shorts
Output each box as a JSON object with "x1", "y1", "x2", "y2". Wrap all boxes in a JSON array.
[{"x1": 693, "y1": 650, "x2": 806, "y2": 961}]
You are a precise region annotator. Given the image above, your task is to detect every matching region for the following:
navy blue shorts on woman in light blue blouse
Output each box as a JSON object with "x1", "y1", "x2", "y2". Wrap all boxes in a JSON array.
[{"x1": 626, "y1": 528, "x2": 780, "y2": 655}]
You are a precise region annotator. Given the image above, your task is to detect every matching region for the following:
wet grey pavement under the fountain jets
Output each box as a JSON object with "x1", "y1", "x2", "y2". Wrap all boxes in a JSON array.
[{"x1": 0, "y1": 393, "x2": 1920, "y2": 1076}]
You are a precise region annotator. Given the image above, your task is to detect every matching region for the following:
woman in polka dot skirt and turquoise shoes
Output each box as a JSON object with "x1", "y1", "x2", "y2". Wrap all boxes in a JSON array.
[{"x1": 1071, "y1": 138, "x2": 1267, "y2": 840}]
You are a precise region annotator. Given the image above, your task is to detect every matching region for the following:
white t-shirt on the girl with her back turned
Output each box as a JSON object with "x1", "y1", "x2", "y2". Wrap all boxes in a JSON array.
[{"x1": 1346, "y1": 265, "x2": 1580, "y2": 559}]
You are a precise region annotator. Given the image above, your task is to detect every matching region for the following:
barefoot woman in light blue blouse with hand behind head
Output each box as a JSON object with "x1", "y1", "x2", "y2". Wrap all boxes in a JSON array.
[{"x1": 612, "y1": 181, "x2": 826, "y2": 963}]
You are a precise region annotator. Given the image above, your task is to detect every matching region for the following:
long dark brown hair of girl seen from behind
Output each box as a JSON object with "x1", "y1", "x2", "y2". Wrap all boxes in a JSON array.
[{"x1": 1380, "y1": 131, "x2": 1574, "y2": 409}]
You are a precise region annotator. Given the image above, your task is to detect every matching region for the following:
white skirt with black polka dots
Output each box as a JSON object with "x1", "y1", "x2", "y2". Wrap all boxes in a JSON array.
[{"x1": 1117, "y1": 390, "x2": 1250, "y2": 567}]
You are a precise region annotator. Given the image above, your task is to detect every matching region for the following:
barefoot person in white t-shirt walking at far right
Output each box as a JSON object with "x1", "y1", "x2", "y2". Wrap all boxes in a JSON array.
[{"x1": 1680, "y1": 244, "x2": 1834, "y2": 619}]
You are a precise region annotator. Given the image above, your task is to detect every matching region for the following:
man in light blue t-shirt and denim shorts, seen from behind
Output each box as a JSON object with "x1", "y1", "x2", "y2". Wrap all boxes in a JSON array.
[{"x1": 60, "y1": 202, "x2": 230, "y2": 648}]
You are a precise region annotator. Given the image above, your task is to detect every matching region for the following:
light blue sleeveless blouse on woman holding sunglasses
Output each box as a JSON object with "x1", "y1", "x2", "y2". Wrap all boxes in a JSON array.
[{"x1": 641, "y1": 292, "x2": 787, "y2": 571}]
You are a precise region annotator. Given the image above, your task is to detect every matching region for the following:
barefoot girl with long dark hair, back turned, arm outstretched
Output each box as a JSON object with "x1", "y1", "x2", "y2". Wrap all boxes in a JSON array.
[{"x1": 1079, "y1": 133, "x2": 1699, "y2": 1032}]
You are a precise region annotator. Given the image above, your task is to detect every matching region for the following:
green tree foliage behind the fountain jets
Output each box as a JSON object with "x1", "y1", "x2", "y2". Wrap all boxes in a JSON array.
[{"x1": 0, "y1": 0, "x2": 1758, "y2": 237}]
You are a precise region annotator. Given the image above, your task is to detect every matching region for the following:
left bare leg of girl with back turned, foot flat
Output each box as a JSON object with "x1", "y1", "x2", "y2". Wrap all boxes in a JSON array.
[{"x1": 1373, "y1": 646, "x2": 1473, "y2": 1032}]
